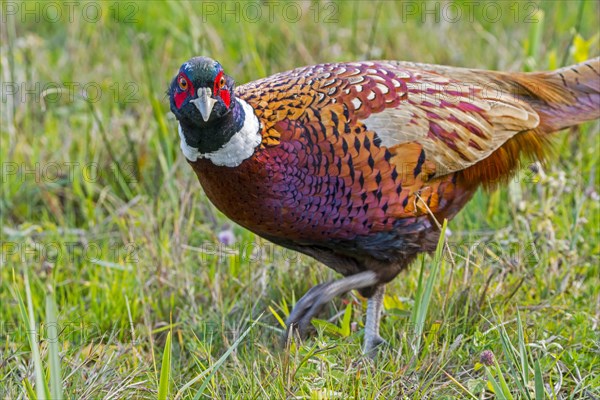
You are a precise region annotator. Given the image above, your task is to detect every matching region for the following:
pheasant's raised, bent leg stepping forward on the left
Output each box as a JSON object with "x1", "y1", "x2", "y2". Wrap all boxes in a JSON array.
[{"x1": 286, "y1": 271, "x2": 377, "y2": 337}]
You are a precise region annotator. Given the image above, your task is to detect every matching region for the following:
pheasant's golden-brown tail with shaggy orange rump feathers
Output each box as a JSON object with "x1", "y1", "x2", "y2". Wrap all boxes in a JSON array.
[{"x1": 462, "y1": 58, "x2": 600, "y2": 189}]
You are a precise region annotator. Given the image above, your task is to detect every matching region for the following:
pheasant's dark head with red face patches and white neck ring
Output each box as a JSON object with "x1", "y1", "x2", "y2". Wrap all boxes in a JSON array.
[{"x1": 169, "y1": 57, "x2": 260, "y2": 166}]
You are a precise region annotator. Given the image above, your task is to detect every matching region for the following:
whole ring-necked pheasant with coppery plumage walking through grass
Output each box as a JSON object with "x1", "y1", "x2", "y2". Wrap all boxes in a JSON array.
[{"x1": 168, "y1": 57, "x2": 600, "y2": 355}]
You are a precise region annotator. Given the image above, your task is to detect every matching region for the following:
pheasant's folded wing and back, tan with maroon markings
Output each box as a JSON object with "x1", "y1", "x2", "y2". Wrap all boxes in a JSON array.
[{"x1": 237, "y1": 61, "x2": 539, "y2": 176}]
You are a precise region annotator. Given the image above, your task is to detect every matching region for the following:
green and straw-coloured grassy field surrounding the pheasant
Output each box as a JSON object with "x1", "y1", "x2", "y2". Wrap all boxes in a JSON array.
[{"x1": 0, "y1": 1, "x2": 600, "y2": 400}]
